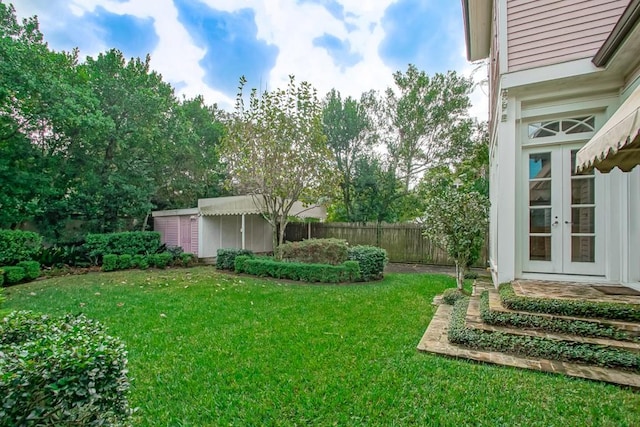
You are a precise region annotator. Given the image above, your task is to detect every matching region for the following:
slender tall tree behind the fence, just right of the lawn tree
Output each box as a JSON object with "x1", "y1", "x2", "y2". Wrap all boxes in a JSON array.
[{"x1": 322, "y1": 89, "x2": 373, "y2": 221}]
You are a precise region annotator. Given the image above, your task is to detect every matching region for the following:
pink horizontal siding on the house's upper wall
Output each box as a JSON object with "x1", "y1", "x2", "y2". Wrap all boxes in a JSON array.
[{"x1": 507, "y1": 0, "x2": 629, "y2": 71}]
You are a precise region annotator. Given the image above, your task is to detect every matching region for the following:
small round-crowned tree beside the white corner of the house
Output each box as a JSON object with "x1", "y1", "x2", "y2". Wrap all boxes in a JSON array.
[{"x1": 423, "y1": 185, "x2": 489, "y2": 290}]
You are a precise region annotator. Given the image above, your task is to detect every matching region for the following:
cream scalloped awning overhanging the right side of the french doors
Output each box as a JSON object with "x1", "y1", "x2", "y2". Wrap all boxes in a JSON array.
[{"x1": 576, "y1": 87, "x2": 640, "y2": 173}]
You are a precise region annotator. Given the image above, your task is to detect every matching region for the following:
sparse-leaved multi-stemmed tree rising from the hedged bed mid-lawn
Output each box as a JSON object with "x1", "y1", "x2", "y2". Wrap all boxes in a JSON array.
[{"x1": 222, "y1": 76, "x2": 336, "y2": 249}]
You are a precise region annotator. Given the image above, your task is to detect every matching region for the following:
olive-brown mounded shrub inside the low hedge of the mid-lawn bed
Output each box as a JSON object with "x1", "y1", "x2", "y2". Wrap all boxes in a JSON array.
[{"x1": 278, "y1": 239, "x2": 347, "y2": 265}]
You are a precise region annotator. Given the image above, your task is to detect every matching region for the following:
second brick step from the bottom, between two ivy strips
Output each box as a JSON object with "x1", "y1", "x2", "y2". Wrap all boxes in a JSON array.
[{"x1": 466, "y1": 294, "x2": 640, "y2": 353}]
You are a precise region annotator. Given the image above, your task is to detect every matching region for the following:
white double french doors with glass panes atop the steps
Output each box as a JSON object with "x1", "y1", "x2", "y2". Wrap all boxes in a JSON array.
[{"x1": 523, "y1": 145, "x2": 605, "y2": 275}]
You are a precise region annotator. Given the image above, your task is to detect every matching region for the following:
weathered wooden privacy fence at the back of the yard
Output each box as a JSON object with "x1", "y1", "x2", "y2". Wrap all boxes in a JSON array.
[{"x1": 285, "y1": 222, "x2": 487, "y2": 267}]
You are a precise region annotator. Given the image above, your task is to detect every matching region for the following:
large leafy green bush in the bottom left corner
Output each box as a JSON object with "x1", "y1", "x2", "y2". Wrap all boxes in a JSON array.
[{"x1": 0, "y1": 311, "x2": 131, "y2": 426}]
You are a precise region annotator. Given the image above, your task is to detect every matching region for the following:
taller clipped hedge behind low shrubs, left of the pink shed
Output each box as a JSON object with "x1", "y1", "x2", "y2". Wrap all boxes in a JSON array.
[{"x1": 85, "y1": 231, "x2": 160, "y2": 257}]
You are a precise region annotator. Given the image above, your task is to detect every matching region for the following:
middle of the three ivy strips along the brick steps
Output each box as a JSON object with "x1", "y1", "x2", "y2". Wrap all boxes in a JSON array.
[{"x1": 480, "y1": 291, "x2": 640, "y2": 341}]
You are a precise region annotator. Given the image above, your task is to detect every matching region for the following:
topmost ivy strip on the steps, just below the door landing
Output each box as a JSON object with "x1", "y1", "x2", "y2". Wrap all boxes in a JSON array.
[{"x1": 499, "y1": 283, "x2": 640, "y2": 322}]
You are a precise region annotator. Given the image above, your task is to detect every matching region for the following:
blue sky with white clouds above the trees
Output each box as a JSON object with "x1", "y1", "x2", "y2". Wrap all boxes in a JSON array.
[{"x1": 15, "y1": 0, "x2": 486, "y2": 116}]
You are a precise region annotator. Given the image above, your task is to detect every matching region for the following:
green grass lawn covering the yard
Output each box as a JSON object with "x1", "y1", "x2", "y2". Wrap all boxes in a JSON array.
[{"x1": 3, "y1": 267, "x2": 640, "y2": 427}]
